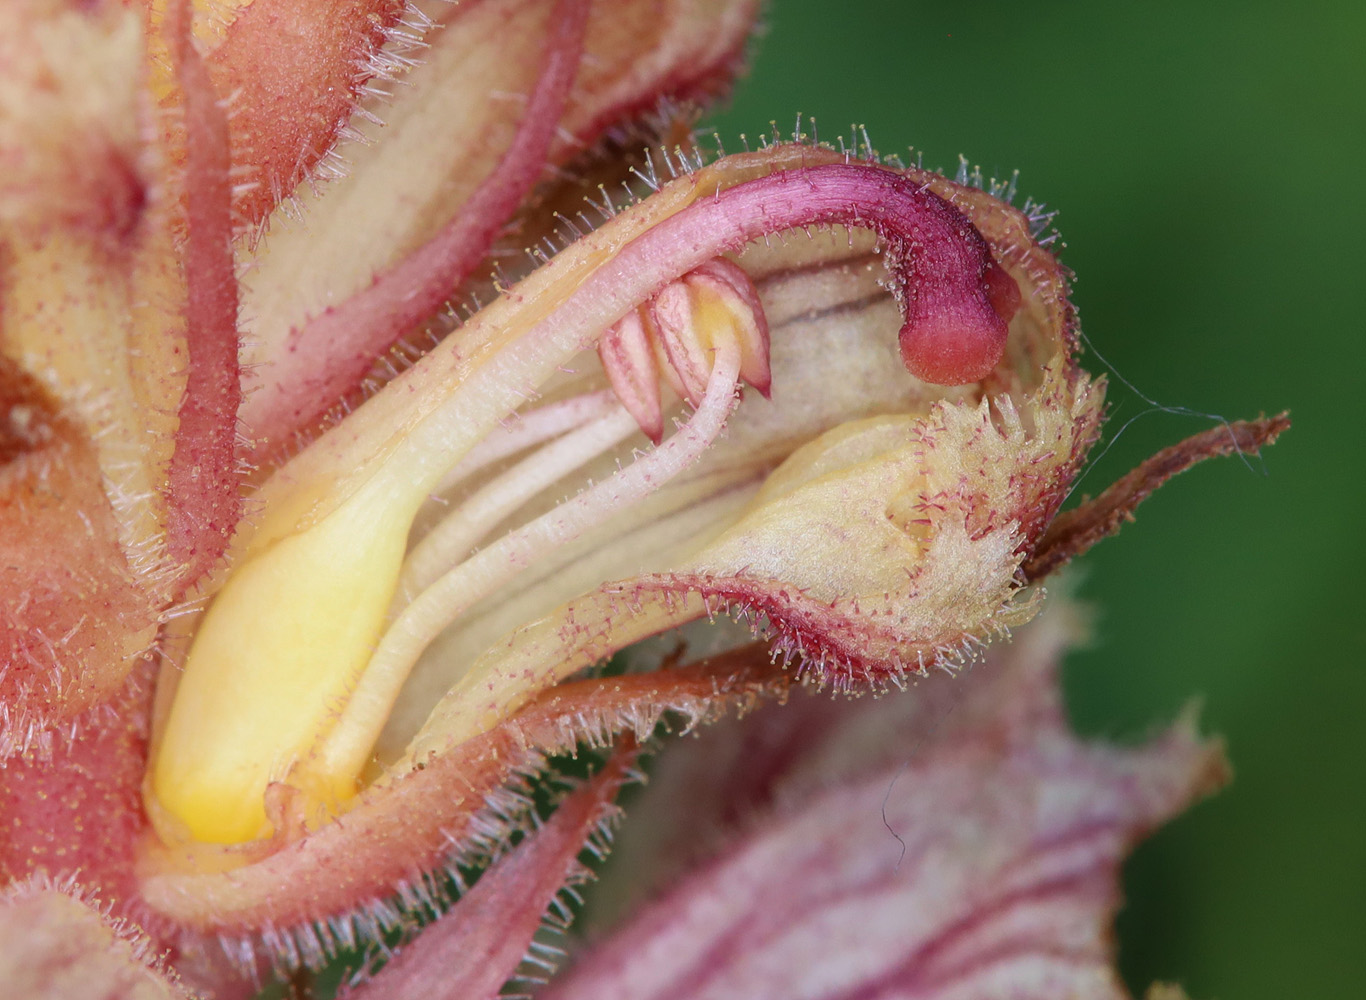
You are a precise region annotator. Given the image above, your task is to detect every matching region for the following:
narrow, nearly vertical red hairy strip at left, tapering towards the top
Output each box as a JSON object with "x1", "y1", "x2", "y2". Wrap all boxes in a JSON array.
[{"x1": 167, "y1": 4, "x2": 242, "y2": 586}]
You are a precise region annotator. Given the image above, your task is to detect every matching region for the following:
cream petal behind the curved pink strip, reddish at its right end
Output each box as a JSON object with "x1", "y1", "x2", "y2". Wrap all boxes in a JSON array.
[{"x1": 243, "y1": 0, "x2": 755, "y2": 401}]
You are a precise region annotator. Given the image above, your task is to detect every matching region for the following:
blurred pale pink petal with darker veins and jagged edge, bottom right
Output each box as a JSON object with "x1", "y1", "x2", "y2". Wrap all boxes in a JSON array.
[{"x1": 549, "y1": 609, "x2": 1225, "y2": 1000}]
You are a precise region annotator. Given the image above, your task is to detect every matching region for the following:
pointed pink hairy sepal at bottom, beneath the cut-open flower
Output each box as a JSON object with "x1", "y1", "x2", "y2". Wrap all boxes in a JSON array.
[{"x1": 351, "y1": 753, "x2": 632, "y2": 1000}]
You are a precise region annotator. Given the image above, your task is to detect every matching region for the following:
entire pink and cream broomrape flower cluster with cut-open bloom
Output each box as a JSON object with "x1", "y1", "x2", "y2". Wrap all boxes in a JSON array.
[{"x1": 0, "y1": 0, "x2": 1285, "y2": 997}]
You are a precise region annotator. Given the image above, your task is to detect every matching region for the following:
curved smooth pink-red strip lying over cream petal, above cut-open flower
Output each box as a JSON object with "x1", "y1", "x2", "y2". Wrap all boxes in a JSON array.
[{"x1": 243, "y1": 0, "x2": 589, "y2": 455}]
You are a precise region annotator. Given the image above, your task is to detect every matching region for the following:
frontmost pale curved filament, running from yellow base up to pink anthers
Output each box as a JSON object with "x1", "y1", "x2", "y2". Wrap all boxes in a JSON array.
[{"x1": 305, "y1": 340, "x2": 740, "y2": 775}]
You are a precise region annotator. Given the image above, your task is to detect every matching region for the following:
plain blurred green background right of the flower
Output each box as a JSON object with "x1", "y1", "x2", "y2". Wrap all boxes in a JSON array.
[{"x1": 712, "y1": 0, "x2": 1366, "y2": 1000}]
